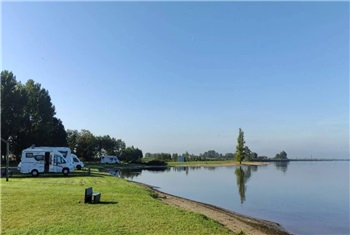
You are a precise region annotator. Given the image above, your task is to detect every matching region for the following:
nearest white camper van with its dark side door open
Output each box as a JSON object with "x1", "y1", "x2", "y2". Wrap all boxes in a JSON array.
[{"x1": 18, "y1": 147, "x2": 74, "y2": 176}]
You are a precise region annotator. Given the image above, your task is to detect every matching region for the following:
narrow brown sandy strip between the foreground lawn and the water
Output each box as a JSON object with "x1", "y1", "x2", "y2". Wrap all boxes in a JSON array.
[{"x1": 128, "y1": 180, "x2": 291, "y2": 235}]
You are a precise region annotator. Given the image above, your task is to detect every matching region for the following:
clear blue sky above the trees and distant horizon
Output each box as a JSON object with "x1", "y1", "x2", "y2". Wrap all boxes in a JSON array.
[{"x1": 2, "y1": 2, "x2": 349, "y2": 158}]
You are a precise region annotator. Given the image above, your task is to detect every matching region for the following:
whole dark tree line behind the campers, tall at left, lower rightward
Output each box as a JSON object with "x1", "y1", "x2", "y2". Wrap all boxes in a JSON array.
[{"x1": 1, "y1": 70, "x2": 142, "y2": 162}]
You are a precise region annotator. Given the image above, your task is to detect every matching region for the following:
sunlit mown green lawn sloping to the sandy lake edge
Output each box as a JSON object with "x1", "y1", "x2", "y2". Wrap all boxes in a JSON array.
[{"x1": 1, "y1": 171, "x2": 232, "y2": 234}]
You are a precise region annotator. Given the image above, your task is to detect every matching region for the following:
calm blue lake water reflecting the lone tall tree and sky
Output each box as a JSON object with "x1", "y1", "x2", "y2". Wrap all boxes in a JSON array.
[{"x1": 119, "y1": 161, "x2": 350, "y2": 234}]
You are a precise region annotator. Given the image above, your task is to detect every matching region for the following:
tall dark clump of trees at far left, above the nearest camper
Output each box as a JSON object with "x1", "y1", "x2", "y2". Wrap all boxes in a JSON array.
[{"x1": 1, "y1": 70, "x2": 67, "y2": 155}]
